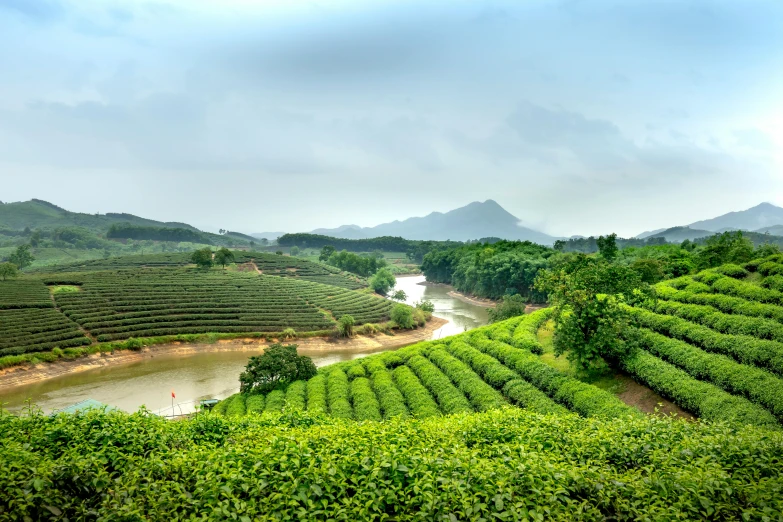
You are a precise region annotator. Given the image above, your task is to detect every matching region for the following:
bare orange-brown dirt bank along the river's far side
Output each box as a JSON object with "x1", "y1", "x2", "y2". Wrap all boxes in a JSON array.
[{"x1": 0, "y1": 317, "x2": 448, "y2": 390}]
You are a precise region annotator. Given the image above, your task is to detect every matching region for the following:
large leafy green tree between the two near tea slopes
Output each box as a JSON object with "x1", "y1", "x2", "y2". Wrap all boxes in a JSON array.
[{"x1": 536, "y1": 254, "x2": 652, "y2": 369}]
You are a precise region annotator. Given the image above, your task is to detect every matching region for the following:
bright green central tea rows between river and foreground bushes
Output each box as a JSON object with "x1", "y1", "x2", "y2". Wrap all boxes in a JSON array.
[{"x1": 214, "y1": 310, "x2": 639, "y2": 420}]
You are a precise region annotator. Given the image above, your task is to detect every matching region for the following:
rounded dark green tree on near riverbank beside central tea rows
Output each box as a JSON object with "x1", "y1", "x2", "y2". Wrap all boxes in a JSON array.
[{"x1": 239, "y1": 343, "x2": 317, "y2": 393}]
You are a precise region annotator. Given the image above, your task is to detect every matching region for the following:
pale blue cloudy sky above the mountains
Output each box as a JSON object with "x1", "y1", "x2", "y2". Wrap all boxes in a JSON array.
[{"x1": 0, "y1": 0, "x2": 783, "y2": 236}]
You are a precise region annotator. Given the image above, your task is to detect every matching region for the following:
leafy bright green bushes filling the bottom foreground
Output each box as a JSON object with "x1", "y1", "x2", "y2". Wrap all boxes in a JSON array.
[{"x1": 0, "y1": 408, "x2": 783, "y2": 521}]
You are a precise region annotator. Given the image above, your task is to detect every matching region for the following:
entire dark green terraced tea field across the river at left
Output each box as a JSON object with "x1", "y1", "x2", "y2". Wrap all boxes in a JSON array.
[{"x1": 0, "y1": 267, "x2": 392, "y2": 355}]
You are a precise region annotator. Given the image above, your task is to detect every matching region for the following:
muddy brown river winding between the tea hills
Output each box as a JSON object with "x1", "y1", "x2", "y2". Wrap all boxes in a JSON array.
[{"x1": 0, "y1": 276, "x2": 487, "y2": 414}]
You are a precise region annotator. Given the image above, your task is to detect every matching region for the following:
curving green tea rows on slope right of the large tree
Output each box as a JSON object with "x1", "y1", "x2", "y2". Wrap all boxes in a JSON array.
[{"x1": 620, "y1": 256, "x2": 783, "y2": 426}]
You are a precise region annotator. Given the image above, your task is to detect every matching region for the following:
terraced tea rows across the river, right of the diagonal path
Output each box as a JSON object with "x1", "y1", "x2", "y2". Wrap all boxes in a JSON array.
[{"x1": 33, "y1": 268, "x2": 391, "y2": 341}]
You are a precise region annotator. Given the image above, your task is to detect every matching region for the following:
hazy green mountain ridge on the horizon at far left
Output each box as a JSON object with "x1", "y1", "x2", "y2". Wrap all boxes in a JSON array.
[{"x1": 0, "y1": 199, "x2": 198, "y2": 232}]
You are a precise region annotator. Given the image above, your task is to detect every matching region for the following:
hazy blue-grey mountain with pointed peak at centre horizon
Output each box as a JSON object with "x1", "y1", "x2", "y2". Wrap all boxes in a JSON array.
[{"x1": 312, "y1": 199, "x2": 560, "y2": 245}]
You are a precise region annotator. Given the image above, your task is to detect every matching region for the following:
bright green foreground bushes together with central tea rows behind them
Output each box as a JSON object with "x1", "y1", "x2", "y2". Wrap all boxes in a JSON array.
[{"x1": 0, "y1": 311, "x2": 783, "y2": 521}]
